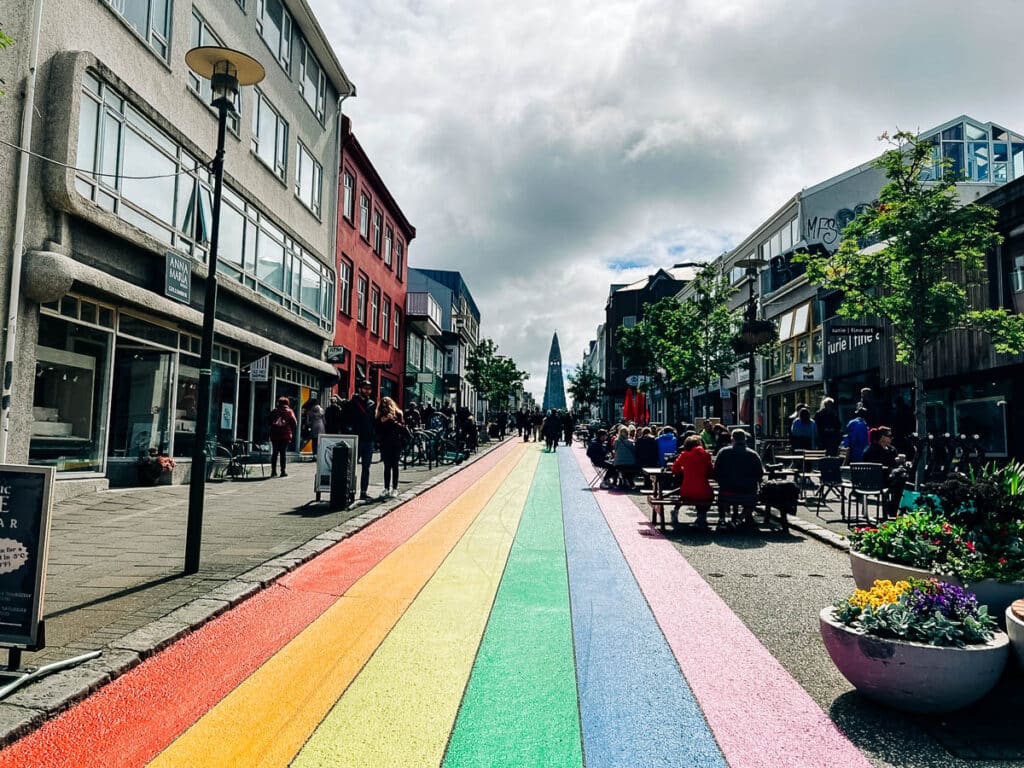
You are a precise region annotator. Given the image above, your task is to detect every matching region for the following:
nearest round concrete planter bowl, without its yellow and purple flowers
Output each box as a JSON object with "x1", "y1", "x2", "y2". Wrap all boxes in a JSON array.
[{"x1": 819, "y1": 606, "x2": 1010, "y2": 713}]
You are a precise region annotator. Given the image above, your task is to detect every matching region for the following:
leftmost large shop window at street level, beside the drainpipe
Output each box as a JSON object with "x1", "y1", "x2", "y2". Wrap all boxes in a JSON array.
[{"x1": 29, "y1": 313, "x2": 113, "y2": 472}]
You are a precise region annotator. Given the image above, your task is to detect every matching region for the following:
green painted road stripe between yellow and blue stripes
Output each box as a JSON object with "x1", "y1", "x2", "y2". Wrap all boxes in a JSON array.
[{"x1": 443, "y1": 454, "x2": 583, "y2": 768}]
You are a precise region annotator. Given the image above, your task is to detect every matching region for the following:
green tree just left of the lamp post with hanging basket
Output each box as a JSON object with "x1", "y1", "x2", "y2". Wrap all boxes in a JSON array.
[{"x1": 680, "y1": 262, "x2": 739, "y2": 421}]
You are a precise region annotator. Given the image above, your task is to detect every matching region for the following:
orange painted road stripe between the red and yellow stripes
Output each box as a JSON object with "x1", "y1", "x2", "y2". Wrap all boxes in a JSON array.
[{"x1": 151, "y1": 450, "x2": 523, "y2": 768}]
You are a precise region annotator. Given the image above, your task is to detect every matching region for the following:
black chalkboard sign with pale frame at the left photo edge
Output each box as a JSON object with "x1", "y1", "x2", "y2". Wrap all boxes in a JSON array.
[{"x1": 0, "y1": 464, "x2": 54, "y2": 648}]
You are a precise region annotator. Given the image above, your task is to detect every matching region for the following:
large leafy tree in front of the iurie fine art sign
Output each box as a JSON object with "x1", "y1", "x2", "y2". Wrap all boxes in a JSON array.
[{"x1": 802, "y1": 126, "x2": 1024, "y2": 471}]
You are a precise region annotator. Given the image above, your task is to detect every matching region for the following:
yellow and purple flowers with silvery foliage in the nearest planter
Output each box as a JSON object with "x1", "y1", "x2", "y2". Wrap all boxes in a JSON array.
[{"x1": 833, "y1": 579, "x2": 996, "y2": 647}]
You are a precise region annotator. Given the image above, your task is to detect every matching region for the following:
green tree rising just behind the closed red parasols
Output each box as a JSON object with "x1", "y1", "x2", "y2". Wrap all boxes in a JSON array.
[{"x1": 615, "y1": 296, "x2": 689, "y2": 421}]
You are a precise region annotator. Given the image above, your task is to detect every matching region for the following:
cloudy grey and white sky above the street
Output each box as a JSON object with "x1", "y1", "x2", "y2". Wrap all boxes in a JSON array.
[{"x1": 309, "y1": 0, "x2": 1024, "y2": 399}]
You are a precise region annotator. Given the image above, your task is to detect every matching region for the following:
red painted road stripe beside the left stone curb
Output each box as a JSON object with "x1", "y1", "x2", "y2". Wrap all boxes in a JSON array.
[{"x1": 0, "y1": 442, "x2": 514, "y2": 768}]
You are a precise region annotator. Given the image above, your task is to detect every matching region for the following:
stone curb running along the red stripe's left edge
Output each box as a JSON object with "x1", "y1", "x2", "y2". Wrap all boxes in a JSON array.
[{"x1": 0, "y1": 438, "x2": 512, "y2": 749}]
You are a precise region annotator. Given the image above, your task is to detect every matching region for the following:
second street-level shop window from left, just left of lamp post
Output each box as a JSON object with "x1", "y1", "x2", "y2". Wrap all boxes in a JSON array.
[{"x1": 109, "y1": 346, "x2": 174, "y2": 458}]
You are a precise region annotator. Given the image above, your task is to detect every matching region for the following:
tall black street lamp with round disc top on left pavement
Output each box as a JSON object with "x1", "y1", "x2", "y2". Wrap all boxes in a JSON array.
[{"x1": 184, "y1": 46, "x2": 265, "y2": 573}]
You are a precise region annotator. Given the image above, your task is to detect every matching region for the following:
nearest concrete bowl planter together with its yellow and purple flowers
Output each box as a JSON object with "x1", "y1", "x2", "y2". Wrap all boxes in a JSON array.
[{"x1": 819, "y1": 579, "x2": 1010, "y2": 712}]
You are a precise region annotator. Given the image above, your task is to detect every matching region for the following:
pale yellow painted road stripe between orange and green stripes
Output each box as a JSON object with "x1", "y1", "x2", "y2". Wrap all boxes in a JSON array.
[{"x1": 292, "y1": 451, "x2": 541, "y2": 768}]
